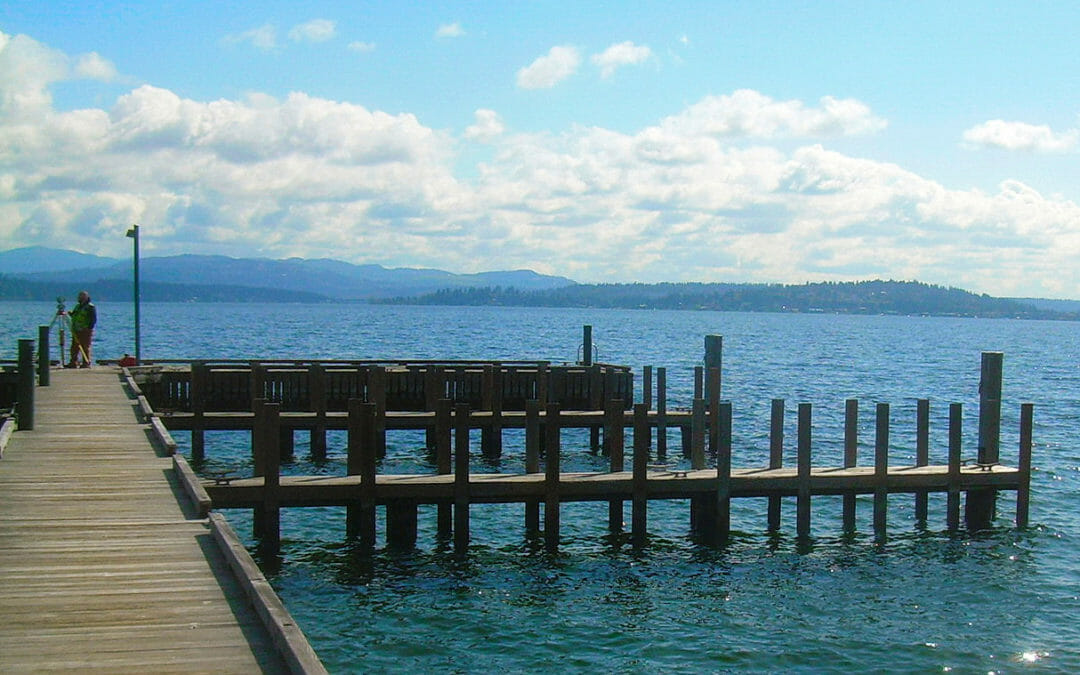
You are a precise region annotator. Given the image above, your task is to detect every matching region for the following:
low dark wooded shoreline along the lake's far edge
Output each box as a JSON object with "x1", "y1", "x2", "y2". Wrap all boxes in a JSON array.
[{"x1": 0, "y1": 275, "x2": 1080, "y2": 321}]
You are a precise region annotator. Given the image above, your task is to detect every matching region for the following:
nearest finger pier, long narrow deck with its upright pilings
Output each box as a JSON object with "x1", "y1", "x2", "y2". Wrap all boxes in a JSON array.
[{"x1": 198, "y1": 401, "x2": 1032, "y2": 550}]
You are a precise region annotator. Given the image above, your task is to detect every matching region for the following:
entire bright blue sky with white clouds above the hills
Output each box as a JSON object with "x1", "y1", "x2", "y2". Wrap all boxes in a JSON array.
[{"x1": 0, "y1": 0, "x2": 1080, "y2": 298}]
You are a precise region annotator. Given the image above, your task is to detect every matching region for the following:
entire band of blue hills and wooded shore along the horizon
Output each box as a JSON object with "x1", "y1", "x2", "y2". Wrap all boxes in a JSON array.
[{"x1": 0, "y1": 246, "x2": 1080, "y2": 320}]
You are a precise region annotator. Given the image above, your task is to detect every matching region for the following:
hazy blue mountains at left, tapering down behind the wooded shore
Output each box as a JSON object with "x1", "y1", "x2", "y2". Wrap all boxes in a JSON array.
[{"x1": 0, "y1": 246, "x2": 575, "y2": 302}]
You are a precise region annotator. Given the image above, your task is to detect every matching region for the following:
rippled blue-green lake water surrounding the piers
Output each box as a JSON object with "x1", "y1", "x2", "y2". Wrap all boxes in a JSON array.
[{"x1": 0, "y1": 302, "x2": 1080, "y2": 673}]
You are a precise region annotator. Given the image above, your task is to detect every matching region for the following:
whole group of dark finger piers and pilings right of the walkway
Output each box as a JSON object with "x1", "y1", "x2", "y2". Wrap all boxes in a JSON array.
[{"x1": 120, "y1": 336, "x2": 1034, "y2": 550}]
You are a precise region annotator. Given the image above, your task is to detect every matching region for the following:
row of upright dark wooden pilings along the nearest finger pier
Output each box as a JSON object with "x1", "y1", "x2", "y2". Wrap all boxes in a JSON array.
[{"x1": 240, "y1": 353, "x2": 1034, "y2": 551}]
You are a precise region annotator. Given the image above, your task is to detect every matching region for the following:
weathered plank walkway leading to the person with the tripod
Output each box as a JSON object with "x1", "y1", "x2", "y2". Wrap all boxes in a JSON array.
[{"x1": 0, "y1": 368, "x2": 322, "y2": 673}]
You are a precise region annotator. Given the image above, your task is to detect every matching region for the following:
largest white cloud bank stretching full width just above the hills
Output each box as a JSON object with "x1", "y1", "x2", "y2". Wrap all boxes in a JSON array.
[{"x1": 0, "y1": 28, "x2": 1080, "y2": 297}]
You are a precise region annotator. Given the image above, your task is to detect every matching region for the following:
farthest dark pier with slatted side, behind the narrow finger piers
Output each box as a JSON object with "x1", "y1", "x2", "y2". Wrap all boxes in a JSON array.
[{"x1": 134, "y1": 361, "x2": 643, "y2": 461}]
